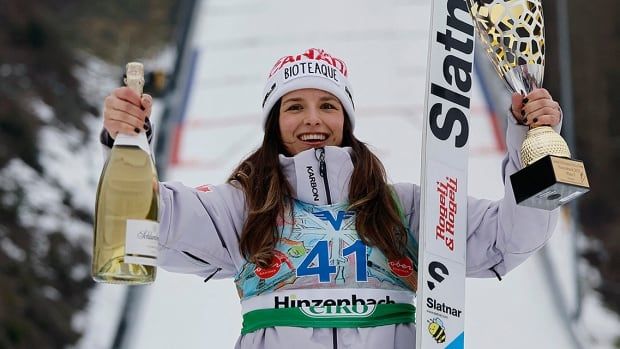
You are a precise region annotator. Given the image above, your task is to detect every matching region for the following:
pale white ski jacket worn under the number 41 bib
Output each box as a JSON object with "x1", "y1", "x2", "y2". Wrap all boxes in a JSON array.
[{"x1": 151, "y1": 118, "x2": 559, "y2": 349}]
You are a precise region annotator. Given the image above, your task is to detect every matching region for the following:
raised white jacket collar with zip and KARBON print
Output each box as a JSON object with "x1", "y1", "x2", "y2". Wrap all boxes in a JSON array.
[{"x1": 280, "y1": 146, "x2": 353, "y2": 205}]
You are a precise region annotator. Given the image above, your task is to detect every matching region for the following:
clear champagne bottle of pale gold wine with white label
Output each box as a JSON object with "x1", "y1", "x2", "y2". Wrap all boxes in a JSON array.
[{"x1": 92, "y1": 63, "x2": 159, "y2": 285}]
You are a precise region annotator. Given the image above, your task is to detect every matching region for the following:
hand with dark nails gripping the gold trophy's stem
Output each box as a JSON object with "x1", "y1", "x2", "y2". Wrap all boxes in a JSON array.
[{"x1": 511, "y1": 88, "x2": 562, "y2": 128}]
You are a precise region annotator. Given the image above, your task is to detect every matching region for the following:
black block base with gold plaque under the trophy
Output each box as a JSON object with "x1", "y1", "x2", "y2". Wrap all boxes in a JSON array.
[{"x1": 510, "y1": 155, "x2": 590, "y2": 211}]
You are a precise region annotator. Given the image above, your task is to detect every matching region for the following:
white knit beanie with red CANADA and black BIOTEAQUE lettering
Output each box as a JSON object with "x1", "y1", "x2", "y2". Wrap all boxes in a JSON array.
[{"x1": 263, "y1": 48, "x2": 355, "y2": 129}]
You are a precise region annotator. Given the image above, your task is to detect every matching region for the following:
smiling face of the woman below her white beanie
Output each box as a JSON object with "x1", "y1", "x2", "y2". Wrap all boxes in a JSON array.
[{"x1": 279, "y1": 88, "x2": 344, "y2": 155}]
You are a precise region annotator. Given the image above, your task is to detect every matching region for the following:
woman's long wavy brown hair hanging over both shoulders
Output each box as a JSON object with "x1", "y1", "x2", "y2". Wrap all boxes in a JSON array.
[{"x1": 228, "y1": 101, "x2": 407, "y2": 267}]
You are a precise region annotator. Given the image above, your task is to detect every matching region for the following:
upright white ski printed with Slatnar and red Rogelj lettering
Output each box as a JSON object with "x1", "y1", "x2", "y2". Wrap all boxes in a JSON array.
[{"x1": 416, "y1": 0, "x2": 474, "y2": 349}]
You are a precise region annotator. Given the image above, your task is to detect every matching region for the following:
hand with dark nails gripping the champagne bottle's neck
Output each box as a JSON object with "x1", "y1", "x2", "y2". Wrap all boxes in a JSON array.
[{"x1": 103, "y1": 87, "x2": 153, "y2": 139}]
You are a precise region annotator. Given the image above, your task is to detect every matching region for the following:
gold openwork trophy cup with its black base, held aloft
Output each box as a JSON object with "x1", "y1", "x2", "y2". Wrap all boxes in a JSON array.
[{"x1": 466, "y1": 0, "x2": 590, "y2": 210}]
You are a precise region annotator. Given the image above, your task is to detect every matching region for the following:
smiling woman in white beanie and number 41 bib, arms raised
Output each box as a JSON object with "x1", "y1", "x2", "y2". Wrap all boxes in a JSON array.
[{"x1": 102, "y1": 49, "x2": 557, "y2": 349}]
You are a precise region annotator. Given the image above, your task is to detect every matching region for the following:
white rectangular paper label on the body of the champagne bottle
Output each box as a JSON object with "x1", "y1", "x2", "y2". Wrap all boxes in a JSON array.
[{"x1": 125, "y1": 219, "x2": 159, "y2": 266}]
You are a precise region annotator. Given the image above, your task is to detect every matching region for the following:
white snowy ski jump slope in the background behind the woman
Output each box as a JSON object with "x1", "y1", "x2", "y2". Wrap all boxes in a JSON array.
[{"x1": 77, "y1": 0, "x2": 620, "y2": 349}]
